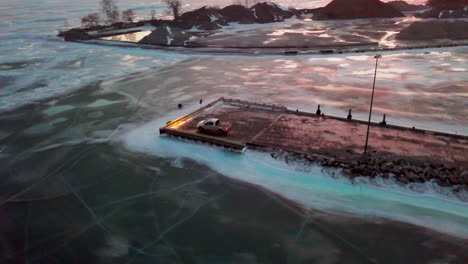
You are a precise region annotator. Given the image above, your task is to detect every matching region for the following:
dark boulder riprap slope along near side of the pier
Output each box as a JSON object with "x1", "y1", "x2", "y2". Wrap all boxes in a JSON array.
[{"x1": 271, "y1": 151, "x2": 468, "y2": 192}]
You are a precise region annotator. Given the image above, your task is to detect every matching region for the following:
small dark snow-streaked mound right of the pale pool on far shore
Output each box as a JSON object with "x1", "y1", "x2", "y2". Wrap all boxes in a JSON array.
[{"x1": 139, "y1": 25, "x2": 192, "y2": 46}]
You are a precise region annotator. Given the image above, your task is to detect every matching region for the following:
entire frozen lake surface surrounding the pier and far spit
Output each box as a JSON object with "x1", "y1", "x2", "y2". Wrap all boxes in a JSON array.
[{"x1": 0, "y1": 0, "x2": 468, "y2": 263}]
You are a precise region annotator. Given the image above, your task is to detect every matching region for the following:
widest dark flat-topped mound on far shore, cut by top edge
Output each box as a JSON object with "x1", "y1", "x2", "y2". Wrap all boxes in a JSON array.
[{"x1": 313, "y1": 0, "x2": 403, "y2": 20}]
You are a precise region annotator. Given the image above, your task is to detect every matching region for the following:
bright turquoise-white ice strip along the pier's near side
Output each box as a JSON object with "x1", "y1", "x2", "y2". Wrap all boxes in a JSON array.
[{"x1": 119, "y1": 108, "x2": 468, "y2": 238}]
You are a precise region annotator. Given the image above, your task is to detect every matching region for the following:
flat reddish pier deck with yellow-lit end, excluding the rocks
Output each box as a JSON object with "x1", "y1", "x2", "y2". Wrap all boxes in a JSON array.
[{"x1": 160, "y1": 98, "x2": 468, "y2": 167}]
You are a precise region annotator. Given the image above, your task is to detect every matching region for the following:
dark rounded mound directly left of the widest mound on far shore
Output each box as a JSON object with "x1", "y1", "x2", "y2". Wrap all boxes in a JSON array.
[{"x1": 250, "y1": 2, "x2": 294, "y2": 23}]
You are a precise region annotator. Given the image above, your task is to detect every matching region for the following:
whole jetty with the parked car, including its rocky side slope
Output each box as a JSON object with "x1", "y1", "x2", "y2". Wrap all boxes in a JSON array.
[{"x1": 159, "y1": 98, "x2": 468, "y2": 188}]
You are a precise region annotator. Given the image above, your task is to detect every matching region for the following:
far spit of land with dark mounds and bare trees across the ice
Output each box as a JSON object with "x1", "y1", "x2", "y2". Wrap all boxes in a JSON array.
[{"x1": 57, "y1": 3, "x2": 468, "y2": 55}]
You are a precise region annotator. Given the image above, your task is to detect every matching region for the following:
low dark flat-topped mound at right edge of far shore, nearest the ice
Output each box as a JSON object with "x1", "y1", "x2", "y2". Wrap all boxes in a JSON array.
[{"x1": 396, "y1": 20, "x2": 468, "y2": 40}]
